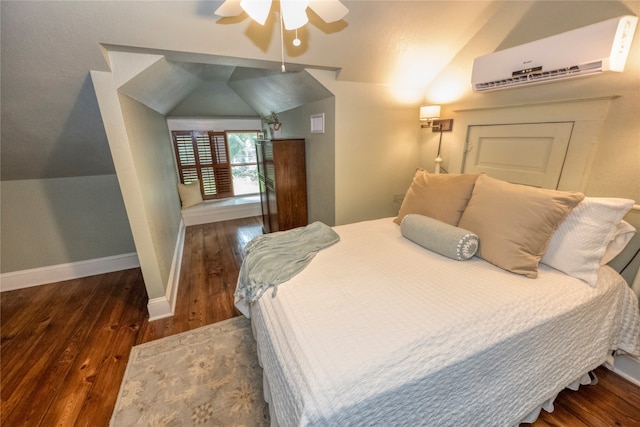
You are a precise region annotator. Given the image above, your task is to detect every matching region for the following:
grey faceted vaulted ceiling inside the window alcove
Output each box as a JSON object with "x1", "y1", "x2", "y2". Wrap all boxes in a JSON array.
[{"x1": 120, "y1": 56, "x2": 331, "y2": 117}]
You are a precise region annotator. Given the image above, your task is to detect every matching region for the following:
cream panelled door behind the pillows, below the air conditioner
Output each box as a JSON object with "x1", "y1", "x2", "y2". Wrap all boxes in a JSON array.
[{"x1": 463, "y1": 122, "x2": 573, "y2": 189}]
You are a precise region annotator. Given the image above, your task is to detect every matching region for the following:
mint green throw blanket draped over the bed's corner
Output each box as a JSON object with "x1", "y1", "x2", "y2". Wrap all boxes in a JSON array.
[{"x1": 235, "y1": 221, "x2": 340, "y2": 310}]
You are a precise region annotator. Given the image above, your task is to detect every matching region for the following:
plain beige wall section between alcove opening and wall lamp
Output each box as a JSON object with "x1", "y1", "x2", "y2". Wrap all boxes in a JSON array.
[{"x1": 310, "y1": 70, "x2": 420, "y2": 225}]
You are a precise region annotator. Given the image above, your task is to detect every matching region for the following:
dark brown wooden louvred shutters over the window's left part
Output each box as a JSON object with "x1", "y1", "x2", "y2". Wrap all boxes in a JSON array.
[{"x1": 171, "y1": 131, "x2": 233, "y2": 200}]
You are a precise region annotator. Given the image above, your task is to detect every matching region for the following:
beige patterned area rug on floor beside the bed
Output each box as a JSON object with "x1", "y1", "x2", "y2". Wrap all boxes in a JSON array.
[{"x1": 110, "y1": 317, "x2": 269, "y2": 427}]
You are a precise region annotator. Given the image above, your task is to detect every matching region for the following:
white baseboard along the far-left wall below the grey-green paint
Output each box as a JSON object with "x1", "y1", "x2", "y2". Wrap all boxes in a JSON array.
[{"x1": 0, "y1": 252, "x2": 140, "y2": 292}]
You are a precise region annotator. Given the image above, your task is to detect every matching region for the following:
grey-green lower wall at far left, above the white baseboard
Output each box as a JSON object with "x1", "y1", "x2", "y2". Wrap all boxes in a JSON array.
[{"x1": 0, "y1": 175, "x2": 136, "y2": 273}]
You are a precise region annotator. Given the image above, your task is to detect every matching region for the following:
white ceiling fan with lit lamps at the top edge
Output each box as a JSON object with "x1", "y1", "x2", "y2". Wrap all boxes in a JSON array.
[{"x1": 215, "y1": 0, "x2": 349, "y2": 30}]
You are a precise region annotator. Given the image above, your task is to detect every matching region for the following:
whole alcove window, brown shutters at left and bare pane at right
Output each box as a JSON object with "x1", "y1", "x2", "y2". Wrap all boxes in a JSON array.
[{"x1": 171, "y1": 131, "x2": 258, "y2": 200}]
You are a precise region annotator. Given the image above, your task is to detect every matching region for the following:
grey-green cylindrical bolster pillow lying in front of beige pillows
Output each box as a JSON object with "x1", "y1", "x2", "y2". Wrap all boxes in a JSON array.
[{"x1": 400, "y1": 214, "x2": 478, "y2": 261}]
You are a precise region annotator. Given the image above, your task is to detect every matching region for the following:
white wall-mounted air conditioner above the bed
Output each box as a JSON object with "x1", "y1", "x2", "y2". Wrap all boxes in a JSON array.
[{"x1": 471, "y1": 16, "x2": 638, "y2": 92}]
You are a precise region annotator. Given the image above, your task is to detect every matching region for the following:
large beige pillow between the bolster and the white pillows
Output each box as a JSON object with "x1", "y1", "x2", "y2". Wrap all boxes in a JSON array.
[{"x1": 458, "y1": 175, "x2": 584, "y2": 278}]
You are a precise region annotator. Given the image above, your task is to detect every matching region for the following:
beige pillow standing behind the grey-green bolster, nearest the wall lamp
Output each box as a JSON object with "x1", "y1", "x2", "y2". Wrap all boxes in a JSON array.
[{"x1": 393, "y1": 169, "x2": 478, "y2": 225}]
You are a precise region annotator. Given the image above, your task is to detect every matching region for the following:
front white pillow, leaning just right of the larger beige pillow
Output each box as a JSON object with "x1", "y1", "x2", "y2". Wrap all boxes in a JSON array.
[{"x1": 541, "y1": 197, "x2": 635, "y2": 286}]
